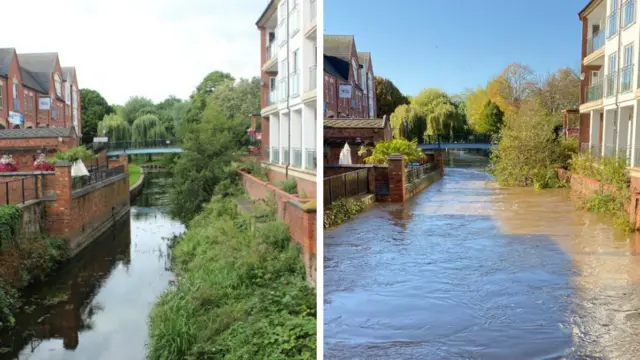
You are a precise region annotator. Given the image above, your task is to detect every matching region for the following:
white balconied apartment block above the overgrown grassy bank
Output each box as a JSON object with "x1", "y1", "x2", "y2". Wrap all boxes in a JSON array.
[{"x1": 257, "y1": 0, "x2": 319, "y2": 174}]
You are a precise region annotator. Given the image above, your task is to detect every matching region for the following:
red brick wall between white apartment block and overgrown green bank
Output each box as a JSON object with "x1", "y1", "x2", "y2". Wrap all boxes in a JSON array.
[{"x1": 238, "y1": 171, "x2": 316, "y2": 284}]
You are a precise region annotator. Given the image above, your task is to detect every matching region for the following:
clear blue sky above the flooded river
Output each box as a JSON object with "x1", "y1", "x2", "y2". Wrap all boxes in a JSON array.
[{"x1": 324, "y1": 0, "x2": 588, "y2": 95}]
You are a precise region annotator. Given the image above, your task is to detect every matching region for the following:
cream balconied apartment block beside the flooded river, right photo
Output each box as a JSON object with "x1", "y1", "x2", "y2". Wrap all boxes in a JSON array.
[{"x1": 579, "y1": 0, "x2": 640, "y2": 167}]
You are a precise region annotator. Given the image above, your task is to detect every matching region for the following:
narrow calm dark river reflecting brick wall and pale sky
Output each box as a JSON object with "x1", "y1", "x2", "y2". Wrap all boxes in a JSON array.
[{"x1": 0, "y1": 173, "x2": 184, "y2": 360}]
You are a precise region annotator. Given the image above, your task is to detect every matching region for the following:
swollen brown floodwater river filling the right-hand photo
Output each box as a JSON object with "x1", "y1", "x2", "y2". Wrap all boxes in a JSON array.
[{"x1": 324, "y1": 156, "x2": 640, "y2": 360}]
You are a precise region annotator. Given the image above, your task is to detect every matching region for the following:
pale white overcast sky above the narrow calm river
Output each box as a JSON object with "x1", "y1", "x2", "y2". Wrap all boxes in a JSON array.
[{"x1": 0, "y1": 0, "x2": 268, "y2": 104}]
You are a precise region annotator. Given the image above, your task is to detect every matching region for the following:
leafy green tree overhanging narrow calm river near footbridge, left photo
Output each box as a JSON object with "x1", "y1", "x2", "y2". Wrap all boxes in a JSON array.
[{"x1": 170, "y1": 104, "x2": 246, "y2": 223}]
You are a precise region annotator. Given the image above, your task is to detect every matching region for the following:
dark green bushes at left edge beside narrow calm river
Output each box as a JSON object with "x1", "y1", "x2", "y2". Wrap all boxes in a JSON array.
[{"x1": 0, "y1": 205, "x2": 67, "y2": 330}]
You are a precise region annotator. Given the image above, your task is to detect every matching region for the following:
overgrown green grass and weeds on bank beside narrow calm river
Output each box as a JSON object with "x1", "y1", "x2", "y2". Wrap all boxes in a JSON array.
[{"x1": 148, "y1": 196, "x2": 316, "y2": 360}]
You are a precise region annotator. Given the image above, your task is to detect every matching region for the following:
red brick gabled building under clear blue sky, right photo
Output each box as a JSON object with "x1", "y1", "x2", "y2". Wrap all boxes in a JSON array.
[{"x1": 323, "y1": 35, "x2": 377, "y2": 119}]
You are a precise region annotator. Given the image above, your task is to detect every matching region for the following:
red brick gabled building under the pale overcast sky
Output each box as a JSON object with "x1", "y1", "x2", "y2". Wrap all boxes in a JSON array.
[{"x1": 0, "y1": 48, "x2": 82, "y2": 135}]
